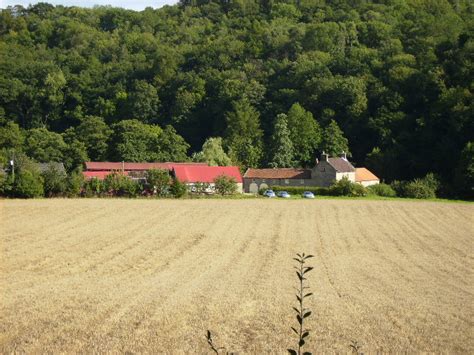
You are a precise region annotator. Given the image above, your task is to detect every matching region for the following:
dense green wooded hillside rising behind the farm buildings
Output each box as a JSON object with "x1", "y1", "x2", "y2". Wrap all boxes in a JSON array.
[{"x1": 0, "y1": 0, "x2": 474, "y2": 197}]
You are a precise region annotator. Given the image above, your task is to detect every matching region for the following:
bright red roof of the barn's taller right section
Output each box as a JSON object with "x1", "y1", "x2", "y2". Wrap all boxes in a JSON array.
[{"x1": 173, "y1": 165, "x2": 242, "y2": 183}]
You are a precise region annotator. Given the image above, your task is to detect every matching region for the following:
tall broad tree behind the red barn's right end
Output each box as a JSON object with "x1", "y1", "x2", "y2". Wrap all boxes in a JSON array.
[{"x1": 226, "y1": 101, "x2": 263, "y2": 168}]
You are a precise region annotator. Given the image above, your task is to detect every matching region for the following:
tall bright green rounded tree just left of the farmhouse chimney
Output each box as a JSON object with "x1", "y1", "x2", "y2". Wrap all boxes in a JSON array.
[{"x1": 287, "y1": 103, "x2": 321, "y2": 166}]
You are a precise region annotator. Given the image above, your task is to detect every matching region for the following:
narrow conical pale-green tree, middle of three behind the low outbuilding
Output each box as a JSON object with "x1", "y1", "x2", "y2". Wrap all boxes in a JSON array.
[{"x1": 268, "y1": 113, "x2": 295, "y2": 168}]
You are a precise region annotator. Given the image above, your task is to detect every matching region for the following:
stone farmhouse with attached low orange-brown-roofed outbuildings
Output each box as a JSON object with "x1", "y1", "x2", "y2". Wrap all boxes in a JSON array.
[{"x1": 244, "y1": 152, "x2": 379, "y2": 193}]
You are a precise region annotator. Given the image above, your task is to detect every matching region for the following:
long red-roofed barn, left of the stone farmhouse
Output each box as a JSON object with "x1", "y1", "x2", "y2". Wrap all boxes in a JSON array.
[{"x1": 83, "y1": 162, "x2": 243, "y2": 192}]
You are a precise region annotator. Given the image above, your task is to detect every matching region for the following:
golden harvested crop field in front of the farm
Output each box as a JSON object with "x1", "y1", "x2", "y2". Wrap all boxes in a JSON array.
[{"x1": 0, "y1": 199, "x2": 474, "y2": 354}]
